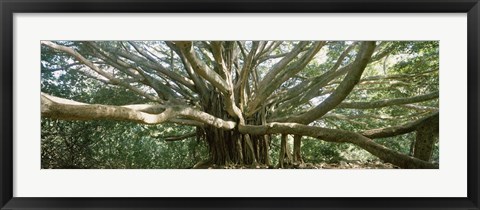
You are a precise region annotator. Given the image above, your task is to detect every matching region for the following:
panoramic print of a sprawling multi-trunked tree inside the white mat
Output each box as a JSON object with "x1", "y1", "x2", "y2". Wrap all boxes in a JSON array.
[{"x1": 41, "y1": 41, "x2": 439, "y2": 168}]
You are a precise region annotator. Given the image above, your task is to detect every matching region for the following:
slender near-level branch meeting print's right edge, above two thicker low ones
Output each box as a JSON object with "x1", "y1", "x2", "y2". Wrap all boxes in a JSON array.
[{"x1": 337, "y1": 92, "x2": 438, "y2": 109}]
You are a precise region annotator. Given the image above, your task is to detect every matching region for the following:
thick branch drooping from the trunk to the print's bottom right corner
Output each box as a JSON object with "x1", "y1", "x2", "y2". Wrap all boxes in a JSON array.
[{"x1": 239, "y1": 123, "x2": 438, "y2": 168}]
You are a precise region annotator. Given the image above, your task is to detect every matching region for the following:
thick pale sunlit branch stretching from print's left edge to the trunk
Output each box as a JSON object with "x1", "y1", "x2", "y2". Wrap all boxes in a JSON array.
[{"x1": 41, "y1": 93, "x2": 236, "y2": 130}]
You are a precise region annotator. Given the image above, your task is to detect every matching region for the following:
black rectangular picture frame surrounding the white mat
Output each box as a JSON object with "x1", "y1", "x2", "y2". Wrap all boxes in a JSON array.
[{"x1": 0, "y1": 0, "x2": 480, "y2": 209}]
